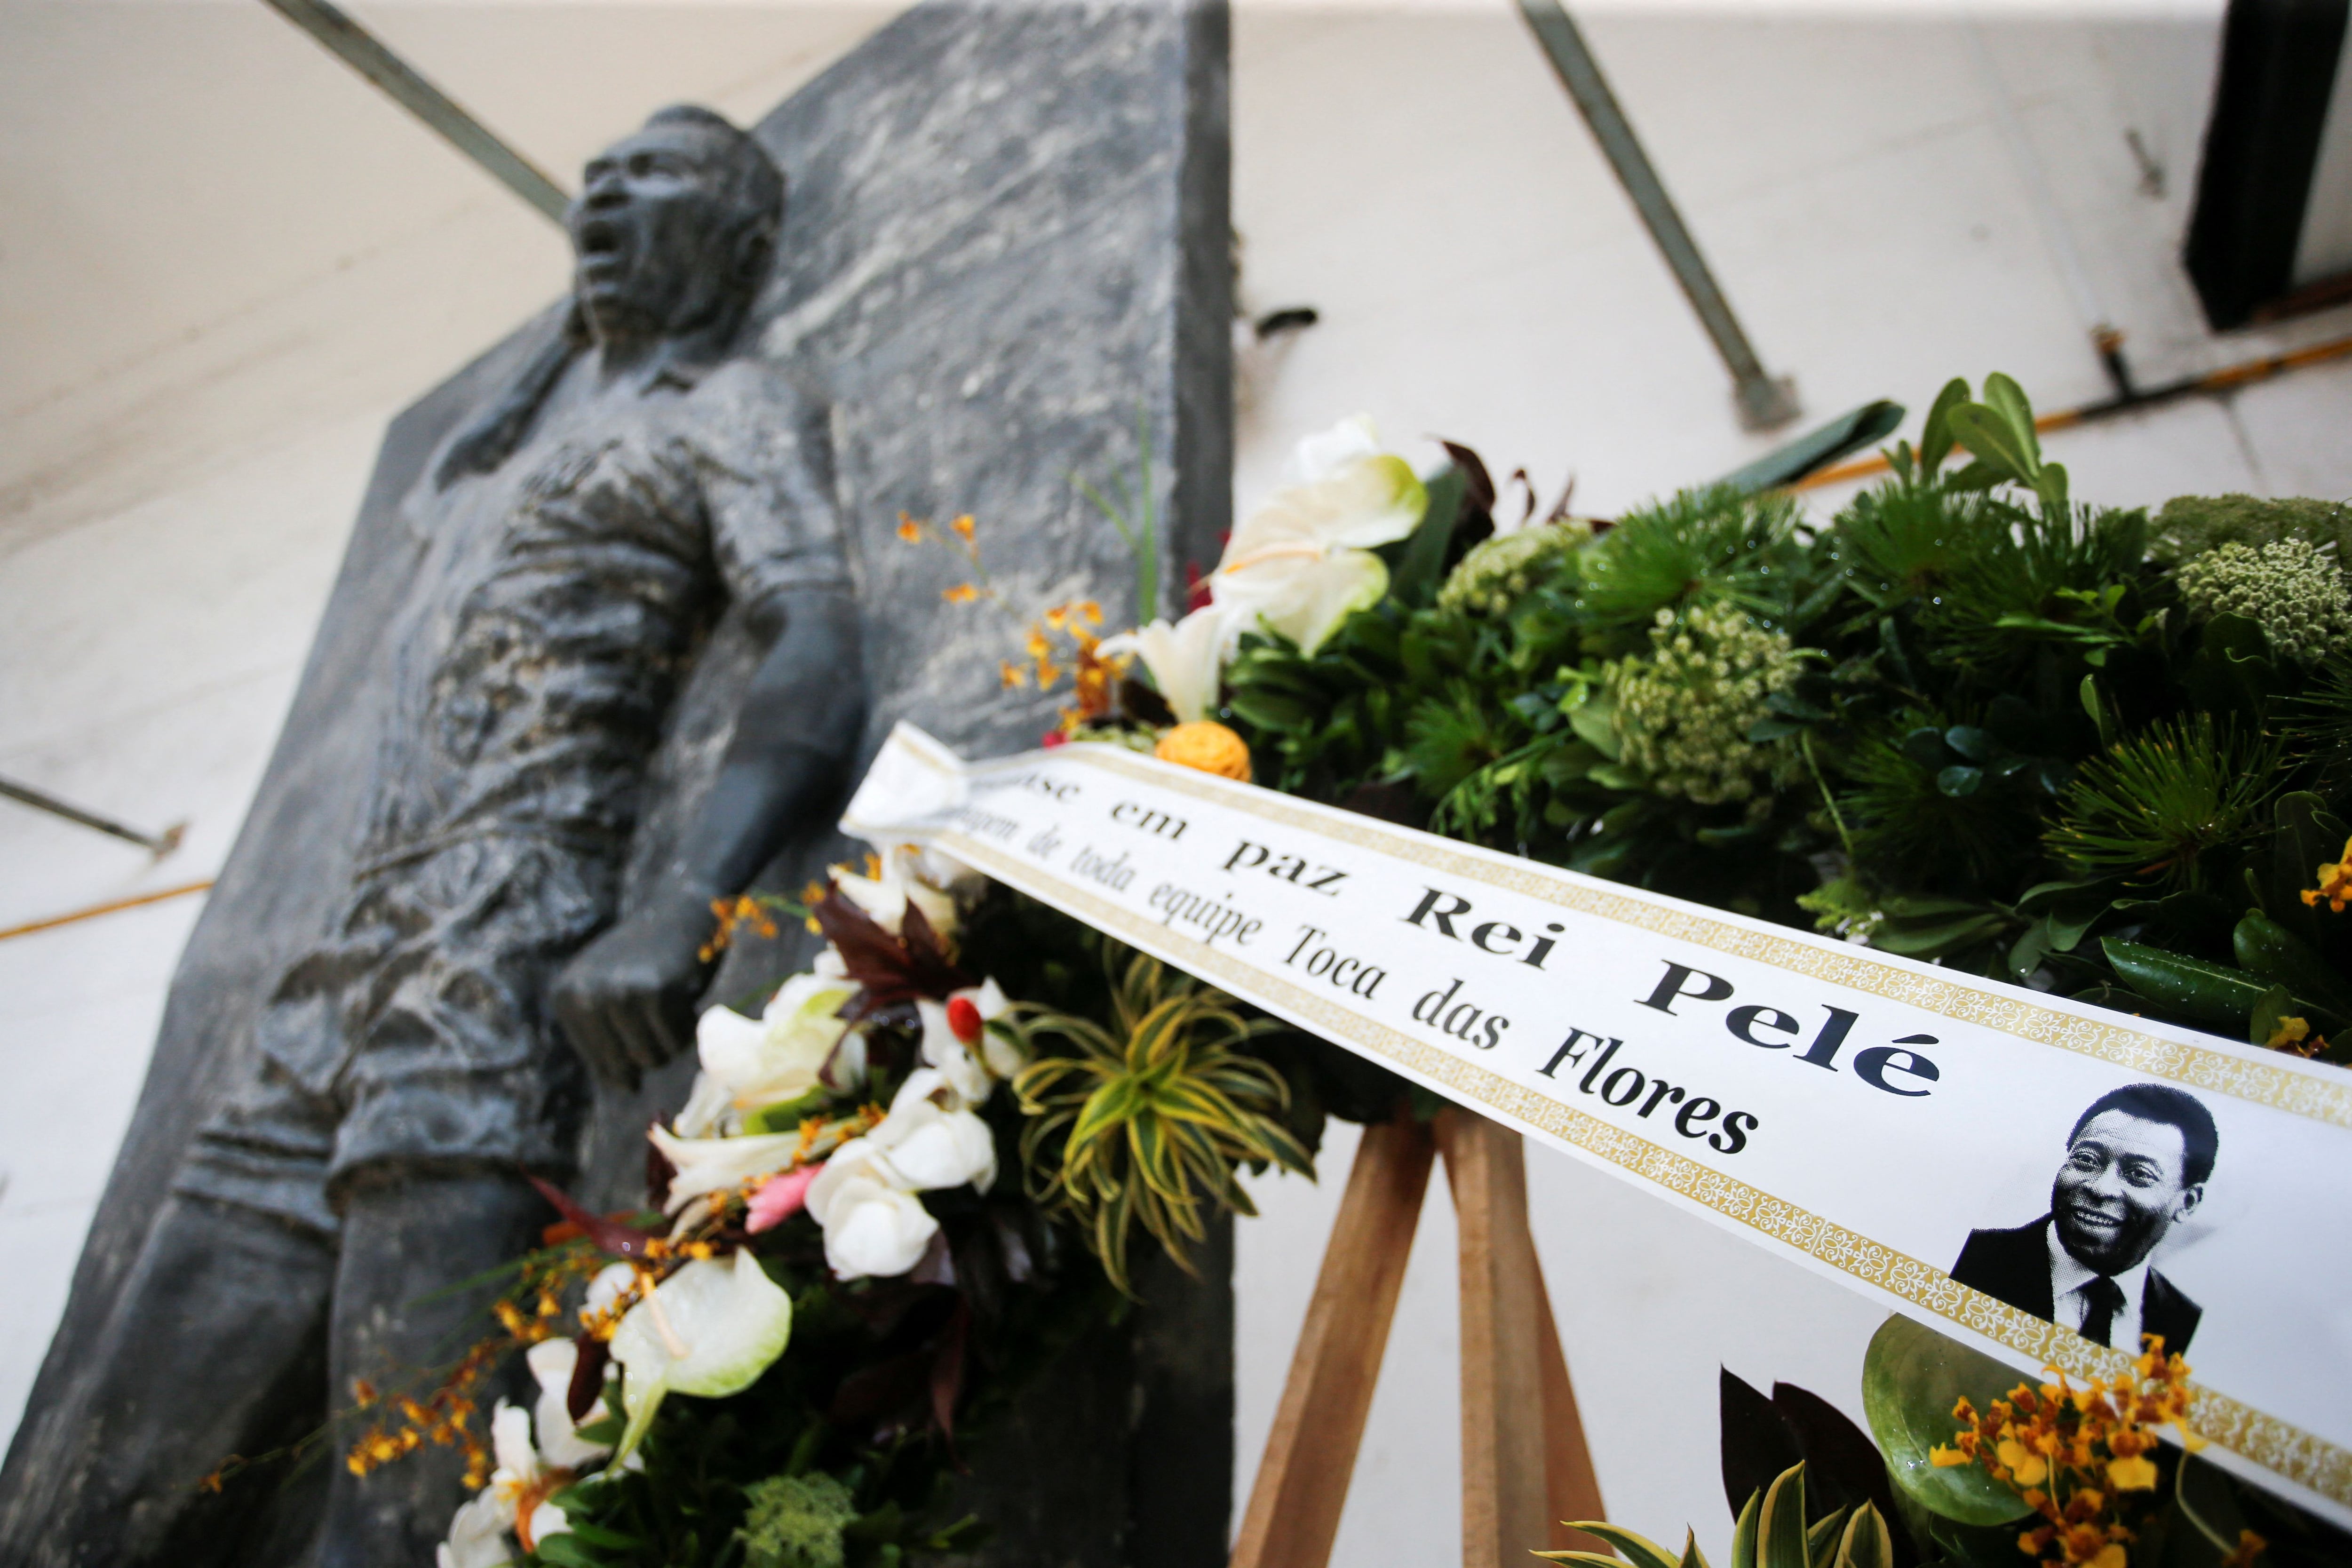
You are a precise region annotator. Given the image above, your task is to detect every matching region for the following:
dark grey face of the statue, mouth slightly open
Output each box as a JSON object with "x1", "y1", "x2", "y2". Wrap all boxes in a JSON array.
[{"x1": 567, "y1": 122, "x2": 739, "y2": 343}]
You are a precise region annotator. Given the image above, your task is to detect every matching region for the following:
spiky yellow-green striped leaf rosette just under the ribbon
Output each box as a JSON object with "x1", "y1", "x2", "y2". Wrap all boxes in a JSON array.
[{"x1": 1011, "y1": 952, "x2": 1312, "y2": 1290}]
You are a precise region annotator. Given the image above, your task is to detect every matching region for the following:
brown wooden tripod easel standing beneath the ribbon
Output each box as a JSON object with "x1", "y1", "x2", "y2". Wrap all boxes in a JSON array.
[{"x1": 1230, "y1": 1110, "x2": 1606, "y2": 1568}]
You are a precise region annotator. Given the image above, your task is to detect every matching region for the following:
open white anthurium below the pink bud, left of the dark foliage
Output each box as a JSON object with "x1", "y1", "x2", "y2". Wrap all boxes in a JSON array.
[{"x1": 612, "y1": 1248, "x2": 793, "y2": 1457}]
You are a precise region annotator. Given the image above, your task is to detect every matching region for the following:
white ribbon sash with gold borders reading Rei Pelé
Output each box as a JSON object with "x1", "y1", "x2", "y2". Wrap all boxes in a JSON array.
[{"x1": 842, "y1": 724, "x2": 2352, "y2": 1521}]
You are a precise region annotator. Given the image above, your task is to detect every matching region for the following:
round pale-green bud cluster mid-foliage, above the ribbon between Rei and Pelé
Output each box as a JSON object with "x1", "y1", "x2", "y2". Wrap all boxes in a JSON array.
[{"x1": 1606, "y1": 604, "x2": 1799, "y2": 806}]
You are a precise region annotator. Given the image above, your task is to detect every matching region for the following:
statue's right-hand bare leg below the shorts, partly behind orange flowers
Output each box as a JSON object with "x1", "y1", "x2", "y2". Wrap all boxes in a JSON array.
[{"x1": 318, "y1": 1166, "x2": 548, "y2": 1568}]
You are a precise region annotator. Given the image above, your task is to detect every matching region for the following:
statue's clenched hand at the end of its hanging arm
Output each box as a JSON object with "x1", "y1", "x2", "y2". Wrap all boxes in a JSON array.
[{"x1": 553, "y1": 893, "x2": 715, "y2": 1089}]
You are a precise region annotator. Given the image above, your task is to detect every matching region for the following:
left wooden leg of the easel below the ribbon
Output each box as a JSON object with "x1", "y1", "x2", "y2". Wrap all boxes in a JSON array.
[{"x1": 1232, "y1": 1117, "x2": 1437, "y2": 1568}]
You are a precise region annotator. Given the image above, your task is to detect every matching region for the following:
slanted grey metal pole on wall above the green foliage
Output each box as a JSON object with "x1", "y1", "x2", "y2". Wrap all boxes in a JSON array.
[{"x1": 1519, "y1": 0, "x2": 1799, "y2": 430}]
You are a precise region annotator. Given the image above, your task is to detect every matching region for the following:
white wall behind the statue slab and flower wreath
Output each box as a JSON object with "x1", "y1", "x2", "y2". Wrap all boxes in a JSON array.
[{"x1": 0, "y1": 0, "x2": 2352, "y2": 1563}]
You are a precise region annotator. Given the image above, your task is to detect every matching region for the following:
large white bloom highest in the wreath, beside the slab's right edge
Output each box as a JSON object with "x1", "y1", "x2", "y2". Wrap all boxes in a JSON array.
[{"x1": 1209, "y1": 416, "x2": 1430, "y2": 653}]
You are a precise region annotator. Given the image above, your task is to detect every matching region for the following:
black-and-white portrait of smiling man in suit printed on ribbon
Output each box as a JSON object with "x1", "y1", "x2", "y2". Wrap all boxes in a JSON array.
[{"x1": 1952, "y1": 1084, "x2": 2220, "y2": 1354}]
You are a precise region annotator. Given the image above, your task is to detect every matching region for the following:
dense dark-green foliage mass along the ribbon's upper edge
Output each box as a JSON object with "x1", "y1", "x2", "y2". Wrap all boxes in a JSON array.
[{"x1": 1223, "y1": 376, "x2": 2352, "y2": 1039}]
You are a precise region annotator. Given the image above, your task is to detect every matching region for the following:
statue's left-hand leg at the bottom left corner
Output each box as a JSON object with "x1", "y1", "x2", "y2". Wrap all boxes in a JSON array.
[{"x1": 28, "y1": 1196, "x2": 334, "y2": 1568}]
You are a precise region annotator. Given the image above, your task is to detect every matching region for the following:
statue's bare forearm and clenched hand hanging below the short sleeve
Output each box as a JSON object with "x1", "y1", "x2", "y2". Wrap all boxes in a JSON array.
[{"x1": 553, "y1": 588, "x2": 866, "y2": 1086}]
